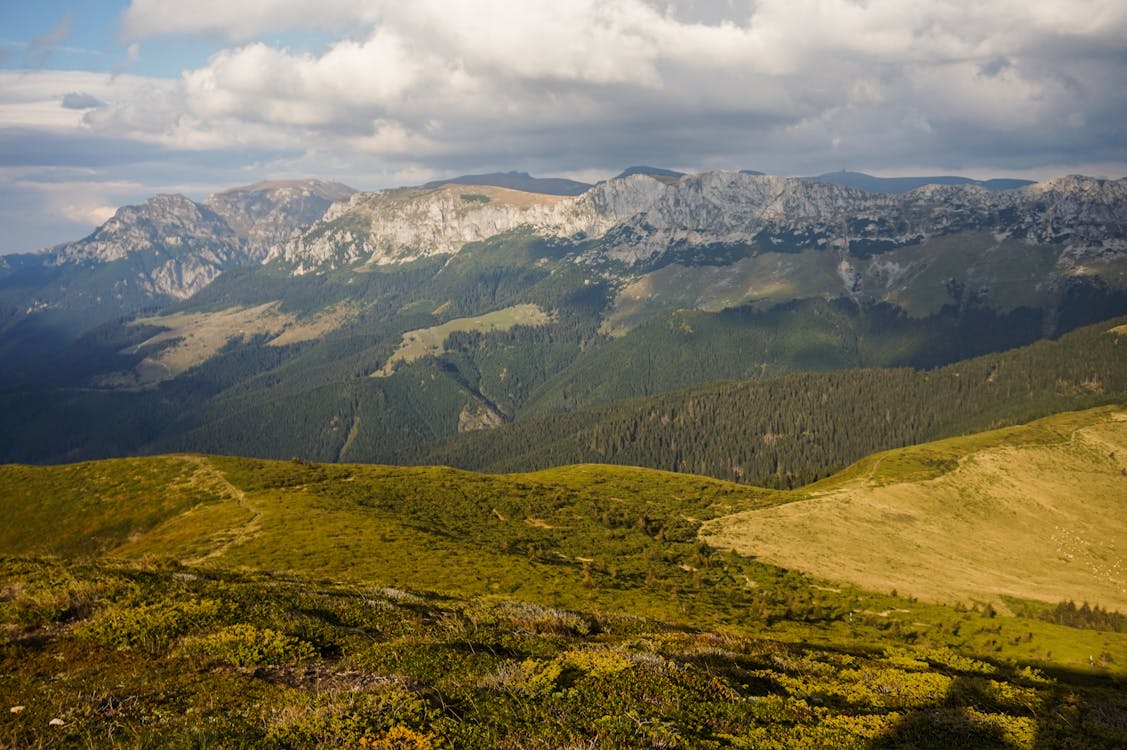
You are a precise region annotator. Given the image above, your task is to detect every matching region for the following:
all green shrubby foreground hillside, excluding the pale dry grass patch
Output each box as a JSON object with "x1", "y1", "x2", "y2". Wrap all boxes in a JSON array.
[{"x1": 0, "y1": 408, "x2": 1127, "y2": 748}]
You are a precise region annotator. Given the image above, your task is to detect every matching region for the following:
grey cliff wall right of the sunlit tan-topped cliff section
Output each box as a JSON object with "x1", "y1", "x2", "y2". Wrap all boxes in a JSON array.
[{"x1": 581, "y1": 173, "x2": 1127, "y2": 264}]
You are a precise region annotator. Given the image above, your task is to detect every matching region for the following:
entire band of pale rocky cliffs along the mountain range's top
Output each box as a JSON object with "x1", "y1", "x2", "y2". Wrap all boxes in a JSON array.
[{"x1": 10, "y1": 171, "x2": 1127, "y2": 327}]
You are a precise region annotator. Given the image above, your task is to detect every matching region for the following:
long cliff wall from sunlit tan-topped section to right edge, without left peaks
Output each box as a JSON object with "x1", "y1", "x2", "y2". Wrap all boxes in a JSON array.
[{"x1": 268, "y1": 171, "x2": 1127, "y2": 273}]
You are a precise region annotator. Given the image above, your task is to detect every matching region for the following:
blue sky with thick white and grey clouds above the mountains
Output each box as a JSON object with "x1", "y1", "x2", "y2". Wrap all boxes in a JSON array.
[{"x1": 0, "y1": 0, "x2": 1127, "y2": 253}]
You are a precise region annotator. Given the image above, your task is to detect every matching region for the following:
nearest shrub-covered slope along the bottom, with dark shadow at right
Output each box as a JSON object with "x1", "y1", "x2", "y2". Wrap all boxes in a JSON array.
[{"x1": 0, "y1": 559, "x2": 1127, "y2": 750}]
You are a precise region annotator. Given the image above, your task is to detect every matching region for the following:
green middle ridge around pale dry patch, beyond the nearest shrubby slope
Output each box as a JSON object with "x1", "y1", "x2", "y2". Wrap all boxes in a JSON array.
[{"x1": 0, "y1": 409, "x2": 1127, "y2": 673}]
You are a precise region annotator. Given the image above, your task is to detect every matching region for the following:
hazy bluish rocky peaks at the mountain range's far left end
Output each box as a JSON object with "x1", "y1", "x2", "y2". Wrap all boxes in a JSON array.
[{"x1": 0, "y1": 180, "x2": 354, "y2": 359}]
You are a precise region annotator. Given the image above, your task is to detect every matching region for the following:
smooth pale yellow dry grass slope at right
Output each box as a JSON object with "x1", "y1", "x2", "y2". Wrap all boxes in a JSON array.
[{"x1": 702, "y1": 407, "x2": 1127, "y2": 611}]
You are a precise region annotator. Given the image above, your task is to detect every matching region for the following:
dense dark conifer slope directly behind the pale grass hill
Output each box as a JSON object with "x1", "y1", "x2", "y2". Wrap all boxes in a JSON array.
[{"x1": 412, "y1": 318, "x2": 1127, "y2": 487}]
